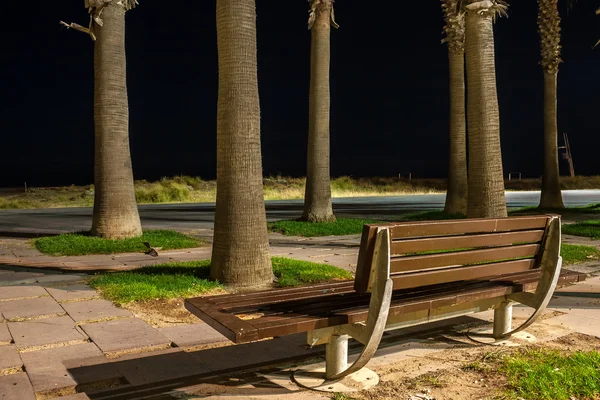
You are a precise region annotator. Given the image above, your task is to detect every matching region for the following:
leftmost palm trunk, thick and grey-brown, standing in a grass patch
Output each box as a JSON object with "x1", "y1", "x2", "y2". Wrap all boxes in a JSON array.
[{"x1": 91, "y1": 2, "x2": 142, "y2": 239}]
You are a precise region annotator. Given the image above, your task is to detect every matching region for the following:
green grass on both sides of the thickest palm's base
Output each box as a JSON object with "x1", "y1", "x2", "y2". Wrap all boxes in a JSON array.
[{"x1": 90, "y1": 257, "x2": 352, "y2": 304}]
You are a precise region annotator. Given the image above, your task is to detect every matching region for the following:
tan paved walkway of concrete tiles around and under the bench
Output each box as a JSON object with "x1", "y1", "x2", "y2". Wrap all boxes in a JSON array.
[{"x1": 0, "y1": 231, "x2": 600, "y2": 400}]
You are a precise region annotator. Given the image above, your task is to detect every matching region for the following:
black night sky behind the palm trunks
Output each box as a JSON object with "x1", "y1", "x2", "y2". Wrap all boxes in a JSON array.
[{"x1": 0, "y1": 0, "x2": 600, "y2": 186}]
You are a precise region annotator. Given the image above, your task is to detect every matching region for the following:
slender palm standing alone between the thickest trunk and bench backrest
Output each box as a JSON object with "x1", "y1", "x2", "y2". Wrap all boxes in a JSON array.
[{"x1": 302, "y1": 0, "x2": 338, "y2": 222}]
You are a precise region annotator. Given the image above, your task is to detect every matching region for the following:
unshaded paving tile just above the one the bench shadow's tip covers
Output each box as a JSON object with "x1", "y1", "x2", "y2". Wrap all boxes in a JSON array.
[{"x1": 8, "y1": 316, "x2": 87, "y2": 348}]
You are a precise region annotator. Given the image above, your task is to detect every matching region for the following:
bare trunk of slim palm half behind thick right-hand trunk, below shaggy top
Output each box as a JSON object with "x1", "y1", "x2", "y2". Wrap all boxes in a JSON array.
[{"x1": 444, "y1": 51, "x2": 467, "y2": 215}]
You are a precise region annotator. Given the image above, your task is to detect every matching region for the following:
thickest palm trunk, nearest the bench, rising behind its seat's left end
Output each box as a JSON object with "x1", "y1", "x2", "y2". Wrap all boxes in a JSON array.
[{"x1": 210, "y1": 0, "x2": 273, "y2": 289}]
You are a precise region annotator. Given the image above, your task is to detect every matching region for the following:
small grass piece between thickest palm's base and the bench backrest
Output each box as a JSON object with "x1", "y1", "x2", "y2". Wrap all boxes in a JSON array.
[{"x1": 272, "y1": 257, "x2": 353, "y2": 287}]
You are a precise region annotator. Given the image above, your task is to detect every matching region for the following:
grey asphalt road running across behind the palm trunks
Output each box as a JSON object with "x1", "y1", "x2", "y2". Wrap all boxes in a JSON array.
[{"x1": 0, "y1": 190, "x2": 600, "y2": 235}]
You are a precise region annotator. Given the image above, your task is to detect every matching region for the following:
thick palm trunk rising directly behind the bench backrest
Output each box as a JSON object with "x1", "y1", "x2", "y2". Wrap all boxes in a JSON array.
[{"x1": 465, "y1": 1, "x2": 507, "y2": 218}]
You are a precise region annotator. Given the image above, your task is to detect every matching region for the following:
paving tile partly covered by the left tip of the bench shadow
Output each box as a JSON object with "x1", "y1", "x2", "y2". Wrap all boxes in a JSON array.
[{"x1": 21, "y1": 343, "x2": 122, "y2": 392}]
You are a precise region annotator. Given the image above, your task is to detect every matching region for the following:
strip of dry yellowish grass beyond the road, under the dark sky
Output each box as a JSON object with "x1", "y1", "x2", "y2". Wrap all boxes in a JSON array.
[{"x1": 0, "y1": 176, "x2": 600, "y2": 209}]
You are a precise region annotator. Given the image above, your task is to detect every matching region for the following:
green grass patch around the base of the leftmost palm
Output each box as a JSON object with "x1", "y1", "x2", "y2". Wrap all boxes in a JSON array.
[{"x1": 33, "y1": 230, "x2": 204, "y2": 256}]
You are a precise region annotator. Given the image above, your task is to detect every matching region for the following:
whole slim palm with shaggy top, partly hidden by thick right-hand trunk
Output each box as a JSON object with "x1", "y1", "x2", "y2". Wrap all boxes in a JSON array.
[{"x1": 442, "y1": 0, "x2": 467, "y2": 215}]
